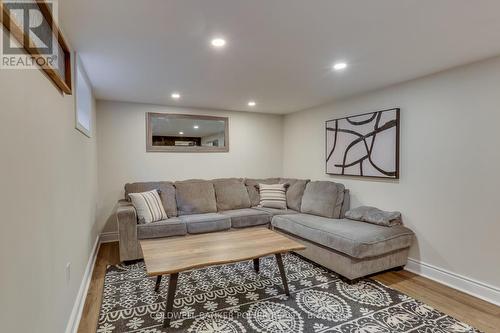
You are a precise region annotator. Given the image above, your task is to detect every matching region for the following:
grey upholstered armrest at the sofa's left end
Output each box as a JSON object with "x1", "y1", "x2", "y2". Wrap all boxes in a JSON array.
[{"x1": 116, "y1": 200, "x2": 142, "y2": 261}]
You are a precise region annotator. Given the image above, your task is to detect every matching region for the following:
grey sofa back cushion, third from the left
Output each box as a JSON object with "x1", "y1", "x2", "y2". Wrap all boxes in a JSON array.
[{"x1": 212, "y1": 178, "x2": 251, "y2": 211}]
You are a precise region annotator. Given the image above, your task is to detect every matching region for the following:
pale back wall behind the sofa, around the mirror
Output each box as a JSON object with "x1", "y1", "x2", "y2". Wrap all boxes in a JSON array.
[{"x1": 97, "y1": 101, "x2": 283, "y2": 231}]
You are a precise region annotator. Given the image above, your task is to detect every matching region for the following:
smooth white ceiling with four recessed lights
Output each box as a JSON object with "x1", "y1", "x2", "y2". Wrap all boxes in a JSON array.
[{"x1": 59, "y1": 0, "x2": 500, "y2": 113}]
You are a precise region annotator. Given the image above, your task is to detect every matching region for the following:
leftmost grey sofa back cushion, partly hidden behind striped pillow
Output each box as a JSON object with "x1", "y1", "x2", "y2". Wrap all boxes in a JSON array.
[{"x1": 125, "y1": 182, "x2": 177, "y2": 217}]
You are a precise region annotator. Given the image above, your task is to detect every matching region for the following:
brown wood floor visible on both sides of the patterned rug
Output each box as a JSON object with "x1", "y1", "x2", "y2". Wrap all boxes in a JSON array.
[{"x1": 78, "y1": 243, "x2": 500, "y2": 333}]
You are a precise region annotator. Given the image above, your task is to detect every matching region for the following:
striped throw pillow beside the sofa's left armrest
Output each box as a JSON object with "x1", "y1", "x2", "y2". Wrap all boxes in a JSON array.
[{"x1": 128, "y1": 190, "x2": 168, "y2": 223}]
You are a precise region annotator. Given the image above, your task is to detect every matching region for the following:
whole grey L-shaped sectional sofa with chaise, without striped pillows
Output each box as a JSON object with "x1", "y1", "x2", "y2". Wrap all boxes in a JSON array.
[{"x1": 116, "y1": 178, "x2": 414, "y2": 280}]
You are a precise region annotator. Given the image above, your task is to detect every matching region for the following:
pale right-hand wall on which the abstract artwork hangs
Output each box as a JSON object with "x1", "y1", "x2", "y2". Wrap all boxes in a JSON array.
[{"x1": 283, "y1": 58, "x2": 500, "y2": 288}]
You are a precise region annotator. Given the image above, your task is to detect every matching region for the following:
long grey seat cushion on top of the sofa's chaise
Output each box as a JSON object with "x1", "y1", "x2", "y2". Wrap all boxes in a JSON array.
[{"x1": 272, "y1": 214, "x2": 413, "y2": 259}]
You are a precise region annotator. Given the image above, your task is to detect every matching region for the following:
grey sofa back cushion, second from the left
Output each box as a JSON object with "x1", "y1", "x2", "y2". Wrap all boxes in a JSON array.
[{"x1": 174, "y1": 180, "x2": 217, "y2": 215}]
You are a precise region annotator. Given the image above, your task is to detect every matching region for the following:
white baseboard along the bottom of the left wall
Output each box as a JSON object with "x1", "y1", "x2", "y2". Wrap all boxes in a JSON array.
[{"x1": 65, "y1": 236, "x2": 101, "y2": 333}]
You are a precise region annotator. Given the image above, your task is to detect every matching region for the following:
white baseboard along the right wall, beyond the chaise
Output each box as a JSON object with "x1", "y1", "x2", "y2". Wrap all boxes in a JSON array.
[{"x1": 405, "y1": 258, "x2": 500, "y2": 305}]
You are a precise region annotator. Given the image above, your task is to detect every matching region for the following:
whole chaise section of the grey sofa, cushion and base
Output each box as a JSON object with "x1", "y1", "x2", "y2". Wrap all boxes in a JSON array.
[{"x1": 272, "y1": 214, "x2": 413, "y2": 280}]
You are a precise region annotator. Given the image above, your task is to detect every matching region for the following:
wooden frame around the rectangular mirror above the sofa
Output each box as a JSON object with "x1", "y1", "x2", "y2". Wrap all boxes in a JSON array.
[{"x1": 146, "y1": 112, "x2": 229, "y2": 153}]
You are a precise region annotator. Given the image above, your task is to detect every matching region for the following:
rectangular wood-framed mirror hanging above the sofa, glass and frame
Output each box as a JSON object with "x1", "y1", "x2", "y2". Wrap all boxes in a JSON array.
[{"x1": 146, "y1": 112, "x2": 229, "y2": 153}]
